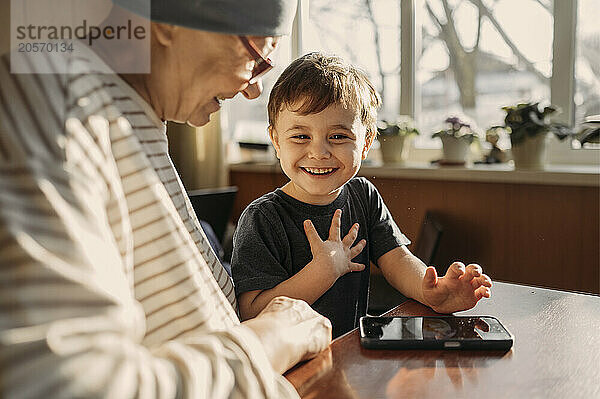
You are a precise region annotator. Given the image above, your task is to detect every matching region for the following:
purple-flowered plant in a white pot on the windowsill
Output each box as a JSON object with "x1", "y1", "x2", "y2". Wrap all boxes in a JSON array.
[{"x1": 431, "y1": 116, "x2": 477, "y2": 165}]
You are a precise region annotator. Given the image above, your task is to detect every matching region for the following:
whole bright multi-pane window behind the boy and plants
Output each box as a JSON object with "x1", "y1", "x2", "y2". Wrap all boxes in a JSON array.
[{"x1": 224, "y1": 0, "x2": 600, "y2": 164}]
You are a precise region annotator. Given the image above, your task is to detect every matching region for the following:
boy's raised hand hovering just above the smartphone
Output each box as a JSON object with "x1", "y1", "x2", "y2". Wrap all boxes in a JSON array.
[{"x1": 422, "y1": 262, "x2": 492, "y2": 313}]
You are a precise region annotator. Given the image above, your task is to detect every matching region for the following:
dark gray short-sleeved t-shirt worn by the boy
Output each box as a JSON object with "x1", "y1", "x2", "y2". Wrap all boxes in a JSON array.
[{"x1": 231, "y1": 177, "x2": 410, "y2": 337}]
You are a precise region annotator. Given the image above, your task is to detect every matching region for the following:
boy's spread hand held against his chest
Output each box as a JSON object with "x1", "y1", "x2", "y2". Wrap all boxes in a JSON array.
[{"x1": 304, "y1": 209, "x2": 367, "y2": 280}]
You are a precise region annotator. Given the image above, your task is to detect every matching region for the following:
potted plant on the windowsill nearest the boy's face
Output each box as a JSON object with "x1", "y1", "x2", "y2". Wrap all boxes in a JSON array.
[{"x1": 377, "y1": 115, "x2": 419, "y2": 163}]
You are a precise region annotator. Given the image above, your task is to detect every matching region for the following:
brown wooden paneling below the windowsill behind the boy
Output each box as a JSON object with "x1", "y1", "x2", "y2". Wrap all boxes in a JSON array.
[{"x1": 230, "y1": 168, "x2": 600, "y2": 294}]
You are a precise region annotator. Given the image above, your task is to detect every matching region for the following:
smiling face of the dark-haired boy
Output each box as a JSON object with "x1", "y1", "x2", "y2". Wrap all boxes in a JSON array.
[{"x1": 269, "y1": 104, "x2": 373, "y2": 205}]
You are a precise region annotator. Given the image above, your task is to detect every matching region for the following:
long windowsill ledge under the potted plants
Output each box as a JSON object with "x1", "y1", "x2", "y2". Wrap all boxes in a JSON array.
[{"x1": 229, "y1": 162, "x2": 600, "y2": 187}]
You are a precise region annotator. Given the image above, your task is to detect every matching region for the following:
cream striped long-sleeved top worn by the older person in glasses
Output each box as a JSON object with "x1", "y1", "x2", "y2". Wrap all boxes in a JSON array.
[{"x1": 0, "y1": 48, "x2": 297, "y2": 398}]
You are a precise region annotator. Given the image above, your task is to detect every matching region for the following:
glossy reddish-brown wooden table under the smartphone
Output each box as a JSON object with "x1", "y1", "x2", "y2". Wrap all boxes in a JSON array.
[{"x1": 286, "y1": 282, "x2": 600, "y2": 399}]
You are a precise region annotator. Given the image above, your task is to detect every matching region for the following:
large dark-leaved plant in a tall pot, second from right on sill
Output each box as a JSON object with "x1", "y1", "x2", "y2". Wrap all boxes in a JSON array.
[{"x1": 502, "y1": 103, "x2": 573, "y2": 169}]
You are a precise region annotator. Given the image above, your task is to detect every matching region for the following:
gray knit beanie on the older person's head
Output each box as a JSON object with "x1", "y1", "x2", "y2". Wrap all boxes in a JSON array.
[{"x1": 113, "y1": 0, "x2": 297, "y2": 36}]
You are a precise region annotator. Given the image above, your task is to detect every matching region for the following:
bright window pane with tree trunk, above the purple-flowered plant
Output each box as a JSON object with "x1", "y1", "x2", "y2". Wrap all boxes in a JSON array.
[{"x1": 416, "y1": 0, "x2": 553, "y2": 150}]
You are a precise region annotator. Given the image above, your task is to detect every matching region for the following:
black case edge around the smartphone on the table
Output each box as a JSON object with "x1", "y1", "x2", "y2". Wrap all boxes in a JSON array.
[{"x1": 359, "y1": 316, "x2": 514, "y2": 351}]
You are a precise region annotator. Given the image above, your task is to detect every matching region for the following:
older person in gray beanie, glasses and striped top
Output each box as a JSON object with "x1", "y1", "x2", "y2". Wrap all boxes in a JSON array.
[{"x1": 0, "y1": 0, "x2": 331, "y2": 398}]
